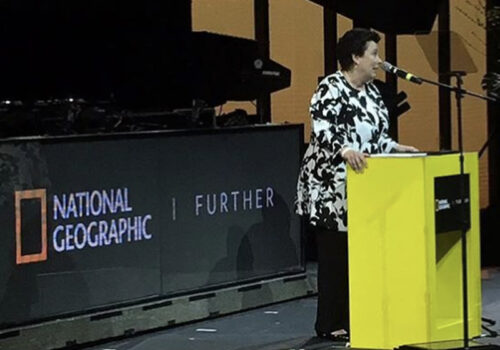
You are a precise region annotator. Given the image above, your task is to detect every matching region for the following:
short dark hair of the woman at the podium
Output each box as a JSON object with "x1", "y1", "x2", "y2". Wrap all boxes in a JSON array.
[{"x1": 337, "y1": 28, "x2": 380, "y2": 70}]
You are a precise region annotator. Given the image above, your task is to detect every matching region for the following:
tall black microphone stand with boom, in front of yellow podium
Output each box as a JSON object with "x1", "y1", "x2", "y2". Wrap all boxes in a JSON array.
[{"x1": 404, "y1": 71, "x2": 500, "y2": 350}]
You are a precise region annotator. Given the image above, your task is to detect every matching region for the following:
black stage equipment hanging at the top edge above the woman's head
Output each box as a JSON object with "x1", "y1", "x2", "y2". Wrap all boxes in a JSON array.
[{"x1": 311, "y1": 0, "x2": 443, "y2": 34}]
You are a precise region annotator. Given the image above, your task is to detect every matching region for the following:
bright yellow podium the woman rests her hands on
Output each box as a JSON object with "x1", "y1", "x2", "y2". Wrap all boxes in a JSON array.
[{"x1": 347, "y1": 153, "x2": 481, "y2": 349}]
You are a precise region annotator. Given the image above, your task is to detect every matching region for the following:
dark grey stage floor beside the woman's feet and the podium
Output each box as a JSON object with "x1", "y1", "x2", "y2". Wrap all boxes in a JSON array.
[{"x1": 86, "y1": 269, "x2": 500, "y2": 350}]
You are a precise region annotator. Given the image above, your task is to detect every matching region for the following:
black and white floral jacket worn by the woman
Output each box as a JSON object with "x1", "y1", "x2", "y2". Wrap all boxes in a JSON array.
[{"x1": 295, "y1": 71, "x2": 397, "y2": 231}]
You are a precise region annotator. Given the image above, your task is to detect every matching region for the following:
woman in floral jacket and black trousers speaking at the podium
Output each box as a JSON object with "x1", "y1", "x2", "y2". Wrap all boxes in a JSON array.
[{"x1": 296, "y1": 28, "x2": 417, "y2": 341}]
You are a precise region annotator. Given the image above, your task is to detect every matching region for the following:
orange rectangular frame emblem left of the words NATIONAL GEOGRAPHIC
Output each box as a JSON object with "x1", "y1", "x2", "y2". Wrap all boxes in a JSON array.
[{"x1": 15, "y1": 189, "x2": 47, "y2": 265}]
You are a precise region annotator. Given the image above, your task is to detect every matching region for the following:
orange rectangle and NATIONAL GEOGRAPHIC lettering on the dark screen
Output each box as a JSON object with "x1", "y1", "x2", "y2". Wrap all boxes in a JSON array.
[{"x1": 15, "y1": 187, "x2": 153, "y2": 265}]
